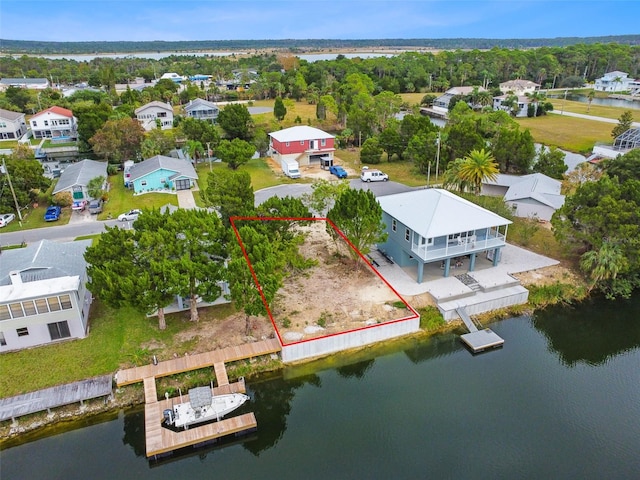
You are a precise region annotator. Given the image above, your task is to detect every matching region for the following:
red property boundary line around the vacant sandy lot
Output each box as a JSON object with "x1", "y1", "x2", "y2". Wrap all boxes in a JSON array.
[{"x1": 229, "y1": 217, "x2": 420, "y2": 347}]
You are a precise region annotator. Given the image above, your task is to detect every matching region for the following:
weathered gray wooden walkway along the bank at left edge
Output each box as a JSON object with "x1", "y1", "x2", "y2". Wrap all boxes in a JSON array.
[{"x1": 0, "y1": 375, "x2": 113, "y2": 422}]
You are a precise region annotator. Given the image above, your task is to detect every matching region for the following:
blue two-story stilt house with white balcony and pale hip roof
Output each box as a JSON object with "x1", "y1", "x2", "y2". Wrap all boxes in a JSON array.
[{"x1": 378, "y1": 188, "x2": 512, "y2": 283}]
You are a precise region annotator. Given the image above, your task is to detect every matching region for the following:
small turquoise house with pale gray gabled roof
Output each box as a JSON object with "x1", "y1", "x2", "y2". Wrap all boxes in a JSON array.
[{"x1": 129, "y1": 155, "x2": 198, "y2": 193}]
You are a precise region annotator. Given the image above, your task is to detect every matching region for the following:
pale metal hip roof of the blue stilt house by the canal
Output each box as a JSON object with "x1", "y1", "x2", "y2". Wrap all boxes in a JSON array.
[{"x1": 378, "y1": 188, "x2": 512, "y2": 238}]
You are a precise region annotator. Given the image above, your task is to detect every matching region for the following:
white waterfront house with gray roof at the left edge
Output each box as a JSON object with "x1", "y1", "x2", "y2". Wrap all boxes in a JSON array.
[{"x1": 0, "y1": 240, "x2": 92, "y2": 352}]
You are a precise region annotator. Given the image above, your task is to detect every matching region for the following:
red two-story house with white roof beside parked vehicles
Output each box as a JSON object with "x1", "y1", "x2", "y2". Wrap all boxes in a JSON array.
[{"x1": 269, "y1": 125, "x2": 335, "y2": 168}]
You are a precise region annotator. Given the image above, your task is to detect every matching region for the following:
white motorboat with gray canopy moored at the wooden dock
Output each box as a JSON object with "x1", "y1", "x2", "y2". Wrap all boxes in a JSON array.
[{"x1": 164, "y1": 387, "x2": 249, "y2": 430}]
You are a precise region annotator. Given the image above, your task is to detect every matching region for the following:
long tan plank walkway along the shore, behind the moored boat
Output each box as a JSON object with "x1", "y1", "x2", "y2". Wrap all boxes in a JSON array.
[{"x1": 116, "y1": 338, "x2": 281, "y2": 387}]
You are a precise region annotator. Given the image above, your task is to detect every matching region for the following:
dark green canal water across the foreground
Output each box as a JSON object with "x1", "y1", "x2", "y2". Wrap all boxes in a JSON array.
[{"x1": 0, "y1": 297, "x2": 640, "y2": 480}]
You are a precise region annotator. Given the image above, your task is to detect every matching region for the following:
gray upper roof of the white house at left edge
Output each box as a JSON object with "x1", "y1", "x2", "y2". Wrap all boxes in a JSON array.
[{"x1": 0, "y1": 240, "x2": 92, "y2": 285}]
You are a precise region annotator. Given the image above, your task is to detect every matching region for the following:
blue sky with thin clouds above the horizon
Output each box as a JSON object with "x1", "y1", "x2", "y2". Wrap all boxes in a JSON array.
[{"x1": 0, "y1": 0, "x2": 640, "y2": 42}]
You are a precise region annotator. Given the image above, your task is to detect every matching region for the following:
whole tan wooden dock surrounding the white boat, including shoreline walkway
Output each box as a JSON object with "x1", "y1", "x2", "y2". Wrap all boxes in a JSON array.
[{"x1": 116, "y1": 339, "x2": 281, "y2": 458}]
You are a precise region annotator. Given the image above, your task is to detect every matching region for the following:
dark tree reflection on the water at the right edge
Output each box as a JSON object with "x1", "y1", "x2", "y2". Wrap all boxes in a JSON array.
[{"x1": 533, "y1": 297, "x2": 640, "y2": 367}]
